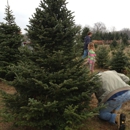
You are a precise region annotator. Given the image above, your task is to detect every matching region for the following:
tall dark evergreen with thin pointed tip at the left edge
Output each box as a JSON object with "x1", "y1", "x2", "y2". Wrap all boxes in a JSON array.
[{"x1": 0, "y1": 3, "x2": 21, "y2": 78}]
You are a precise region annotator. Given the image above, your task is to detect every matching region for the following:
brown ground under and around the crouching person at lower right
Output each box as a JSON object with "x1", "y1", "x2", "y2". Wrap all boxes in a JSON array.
[{"x1": 81, "y1": 95, "x2": 130, "y2": 130}]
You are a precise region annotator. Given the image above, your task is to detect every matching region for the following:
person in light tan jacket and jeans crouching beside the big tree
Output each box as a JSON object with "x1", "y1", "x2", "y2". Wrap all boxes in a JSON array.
[{"x1": 95, "y1": 71, "x2": 130, "y2": 130}]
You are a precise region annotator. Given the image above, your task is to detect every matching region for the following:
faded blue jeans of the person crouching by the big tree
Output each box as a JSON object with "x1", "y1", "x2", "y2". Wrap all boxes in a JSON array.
[{"x1": 99, "y1": 90, "x2": 130, "y2": 123}]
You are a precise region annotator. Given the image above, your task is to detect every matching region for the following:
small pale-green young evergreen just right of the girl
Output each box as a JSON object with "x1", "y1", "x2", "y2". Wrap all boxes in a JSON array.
[{"x1": 96, "y1": 45, "x2": 109, "y2": 68}]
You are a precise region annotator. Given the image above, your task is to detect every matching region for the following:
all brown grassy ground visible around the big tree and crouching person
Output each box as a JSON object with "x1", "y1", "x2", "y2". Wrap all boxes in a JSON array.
[{"x1": 0, "y1": 69, "x2": 130, "y2": 130}]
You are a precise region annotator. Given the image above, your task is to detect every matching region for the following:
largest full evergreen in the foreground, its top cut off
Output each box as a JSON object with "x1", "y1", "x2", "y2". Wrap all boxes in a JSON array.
[{"x1": 1, "y1": 0, "x2": 99, "y2": 130}]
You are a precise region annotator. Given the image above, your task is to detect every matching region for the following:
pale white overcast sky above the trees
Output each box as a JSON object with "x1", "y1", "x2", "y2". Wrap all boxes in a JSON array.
[{"x1": 0, "y1": 0, "x2": 130, "y2": 33}]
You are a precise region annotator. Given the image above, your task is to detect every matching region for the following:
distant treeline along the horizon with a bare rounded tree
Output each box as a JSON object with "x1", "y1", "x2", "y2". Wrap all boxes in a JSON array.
[{"x1": 79, "y1": 22, "x2": 130, "y2": 41}]
